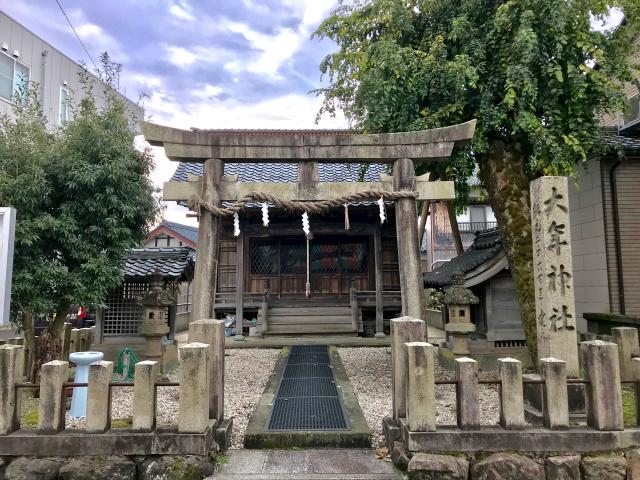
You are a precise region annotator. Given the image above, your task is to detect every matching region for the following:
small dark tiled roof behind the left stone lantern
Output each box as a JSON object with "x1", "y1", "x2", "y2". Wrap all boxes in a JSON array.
[{"x1": 124, "y1": 247, "x2": 195, "y2": 280}]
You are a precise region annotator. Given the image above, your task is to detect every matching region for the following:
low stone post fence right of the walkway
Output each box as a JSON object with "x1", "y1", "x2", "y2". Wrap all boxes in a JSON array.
[{"x1": 384, "y1": 317, "x2": 640, "y2": 478}]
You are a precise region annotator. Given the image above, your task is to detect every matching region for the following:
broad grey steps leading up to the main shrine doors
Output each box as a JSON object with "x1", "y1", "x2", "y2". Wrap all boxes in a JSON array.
[{"x1": 258, "y1": 304, "x2": 357, "y2": 335}]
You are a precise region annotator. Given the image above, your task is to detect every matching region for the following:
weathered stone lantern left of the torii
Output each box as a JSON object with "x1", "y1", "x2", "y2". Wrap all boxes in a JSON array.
[{"x1": 138, "y1": 272, "x2": 176, "y2": 365}]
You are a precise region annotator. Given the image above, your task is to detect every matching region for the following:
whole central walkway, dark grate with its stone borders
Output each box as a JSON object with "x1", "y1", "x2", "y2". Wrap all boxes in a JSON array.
[{"x1": 245, "y1": 345, "x2": 371, "y2": 448}]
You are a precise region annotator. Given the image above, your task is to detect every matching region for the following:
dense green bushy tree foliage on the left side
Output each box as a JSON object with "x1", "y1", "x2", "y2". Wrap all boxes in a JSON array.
[{"x1": 0, "y1": 54, "x2": 158, "y2": 330}]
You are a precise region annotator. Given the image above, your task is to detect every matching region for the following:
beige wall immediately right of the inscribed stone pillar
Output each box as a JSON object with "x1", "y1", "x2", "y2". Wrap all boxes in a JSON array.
[{"x1": 569, "y1": 160, "x2": 610, "y2": 331}]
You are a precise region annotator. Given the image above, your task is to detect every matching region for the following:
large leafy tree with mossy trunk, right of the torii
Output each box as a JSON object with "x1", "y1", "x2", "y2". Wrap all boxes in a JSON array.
[{"x1": 316, "y1": 0, "x2": 640, "y2": 358}]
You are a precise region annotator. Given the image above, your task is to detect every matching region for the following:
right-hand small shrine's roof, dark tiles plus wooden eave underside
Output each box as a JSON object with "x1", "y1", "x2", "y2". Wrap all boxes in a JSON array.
[{"x1": 423, "y1": 228, "x2": 507, "y2": 288}]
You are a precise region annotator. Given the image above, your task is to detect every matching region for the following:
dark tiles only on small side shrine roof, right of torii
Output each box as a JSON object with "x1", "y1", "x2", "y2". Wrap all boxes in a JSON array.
[{"x1": 423, "y1": 228, "x2": 503, "y2": 288}]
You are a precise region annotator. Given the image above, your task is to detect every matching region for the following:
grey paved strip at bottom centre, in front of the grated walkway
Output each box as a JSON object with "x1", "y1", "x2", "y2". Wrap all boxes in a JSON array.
[{"x1": 209, "y1": 449, "x2": 404, "y2": 480}]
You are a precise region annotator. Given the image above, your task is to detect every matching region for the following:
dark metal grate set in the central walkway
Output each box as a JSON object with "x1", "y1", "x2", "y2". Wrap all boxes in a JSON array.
[{"x1": 267, "y1": 345, "x2": 348, "y2": 431}]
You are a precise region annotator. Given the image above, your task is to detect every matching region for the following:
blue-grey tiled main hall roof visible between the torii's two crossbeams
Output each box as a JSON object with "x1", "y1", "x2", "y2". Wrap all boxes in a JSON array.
[{"x1": 171, "y1": 162, "x2": 386, "y2": 182}]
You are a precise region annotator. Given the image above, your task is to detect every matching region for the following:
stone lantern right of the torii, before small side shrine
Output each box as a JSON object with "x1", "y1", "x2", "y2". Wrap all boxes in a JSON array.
[{"x1": 444, "y1": 272, "x2": 479, "y2": 355}]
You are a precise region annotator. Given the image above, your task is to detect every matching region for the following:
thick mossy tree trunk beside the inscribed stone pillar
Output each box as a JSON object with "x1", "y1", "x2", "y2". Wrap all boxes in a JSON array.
[{"x1": 478, "y1": 140, "x2": 538, "y2": 365}]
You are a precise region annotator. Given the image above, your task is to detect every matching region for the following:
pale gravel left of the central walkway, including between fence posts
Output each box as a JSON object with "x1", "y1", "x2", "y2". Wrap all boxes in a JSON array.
[{"x1": 21, "y1": 349, "x2": 280, "y2": 448}]
